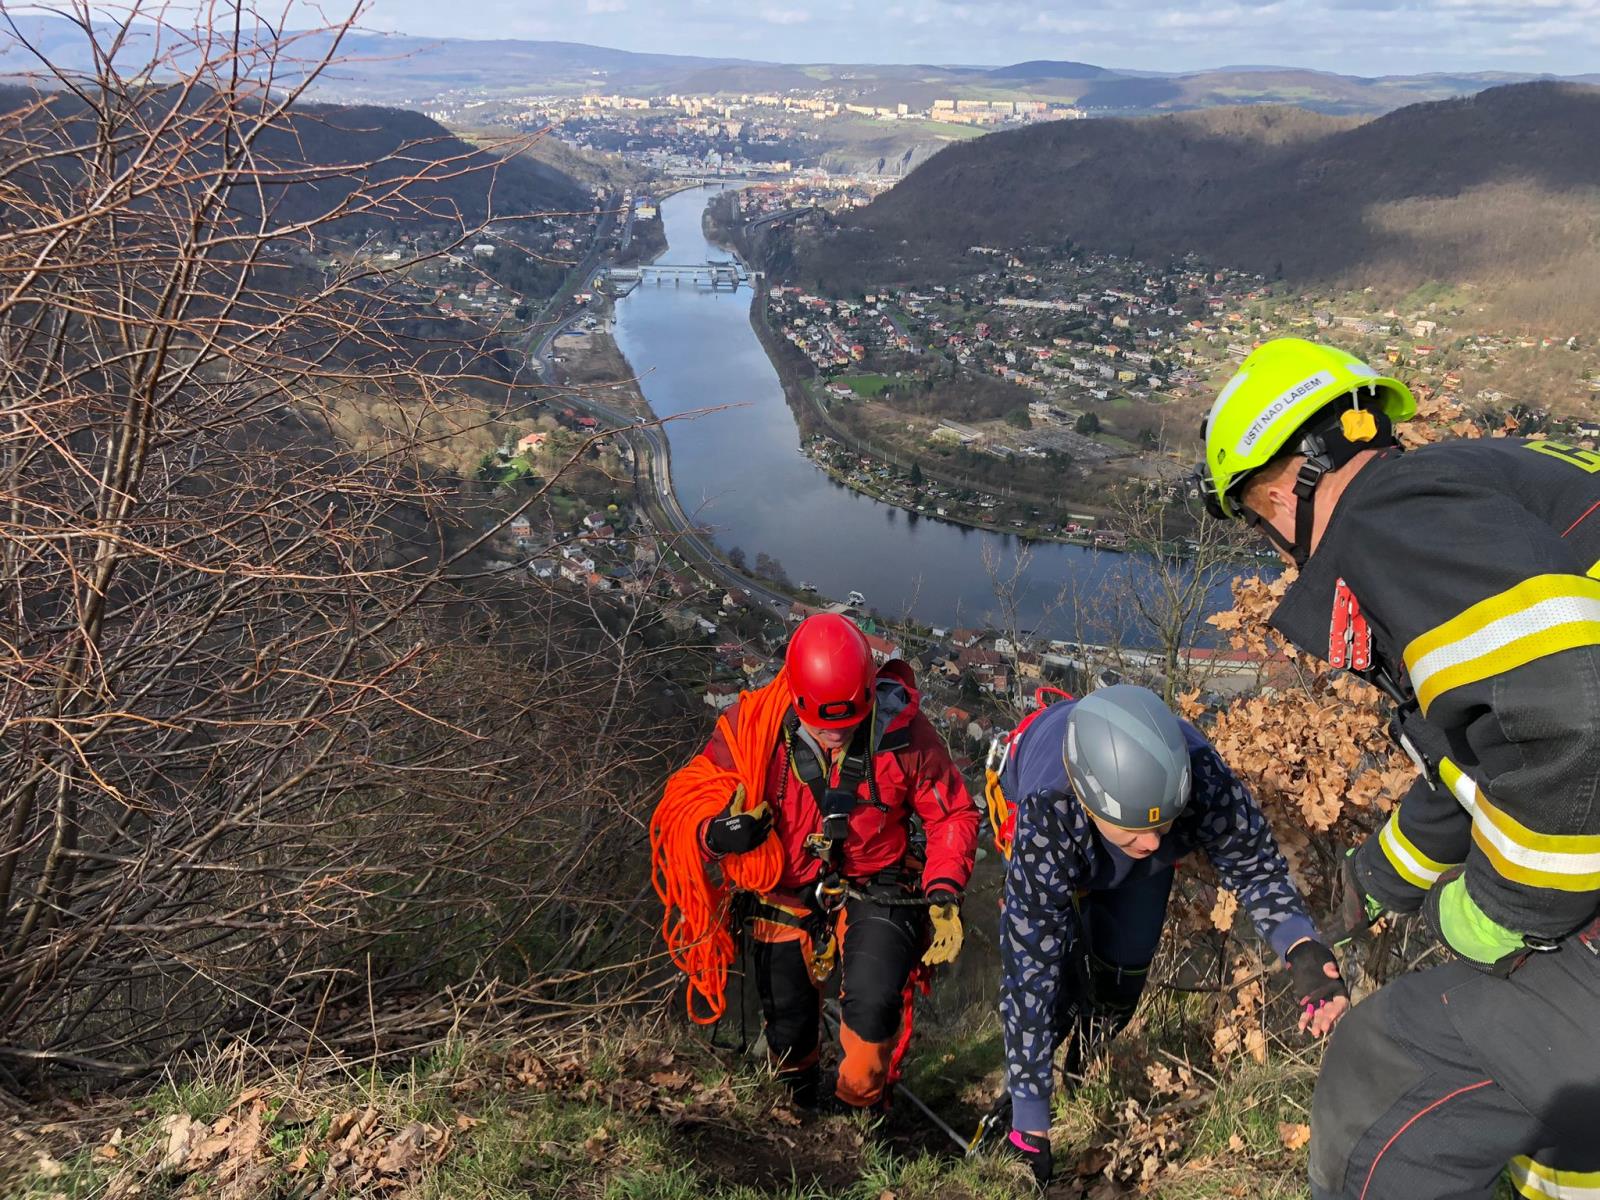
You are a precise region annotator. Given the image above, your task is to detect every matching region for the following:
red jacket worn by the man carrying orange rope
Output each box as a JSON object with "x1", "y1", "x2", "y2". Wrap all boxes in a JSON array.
[{"x1": 702, "y1": 659, "x2": 978, "y2": 891}]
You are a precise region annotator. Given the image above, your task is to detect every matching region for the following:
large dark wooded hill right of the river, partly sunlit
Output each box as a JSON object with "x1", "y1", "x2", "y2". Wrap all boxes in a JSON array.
[{"x1": 795, "y1": 83, "x2": 1600, "y2": 320}]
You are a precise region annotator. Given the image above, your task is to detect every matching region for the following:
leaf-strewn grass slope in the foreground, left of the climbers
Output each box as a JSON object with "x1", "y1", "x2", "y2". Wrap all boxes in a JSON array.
[{"x1": 9, "y1": 1032, "x2": 1018, "y2": 1200}]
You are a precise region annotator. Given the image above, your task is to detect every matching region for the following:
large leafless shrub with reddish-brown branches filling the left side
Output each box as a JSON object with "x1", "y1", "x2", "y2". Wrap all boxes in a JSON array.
[{"x1": 0, "y1": 5, "x2": 675, "y2": 1082}]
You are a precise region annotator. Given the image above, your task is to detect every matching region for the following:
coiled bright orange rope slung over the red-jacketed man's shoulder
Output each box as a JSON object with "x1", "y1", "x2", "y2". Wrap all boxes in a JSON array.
[{"x1": 650, "y1": 672, "x2": 789, "y2": 1026}]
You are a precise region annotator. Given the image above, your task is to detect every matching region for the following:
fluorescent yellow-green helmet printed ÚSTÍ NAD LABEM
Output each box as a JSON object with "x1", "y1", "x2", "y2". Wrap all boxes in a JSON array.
[{"x1": 1197, "y1": 338, "x2": 1416, "y2": 517}]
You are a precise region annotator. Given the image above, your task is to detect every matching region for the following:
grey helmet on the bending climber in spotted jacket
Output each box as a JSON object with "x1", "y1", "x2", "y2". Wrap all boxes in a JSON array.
[{"x1": 1062, "y1": 683, "x2": 1189, "y2": 829}]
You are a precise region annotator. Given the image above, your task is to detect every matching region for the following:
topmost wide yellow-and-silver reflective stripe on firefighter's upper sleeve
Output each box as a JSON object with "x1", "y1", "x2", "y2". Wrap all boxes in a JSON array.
[{"x1": 1403, "y1": 574, "x2": 1600, "y2": 714}]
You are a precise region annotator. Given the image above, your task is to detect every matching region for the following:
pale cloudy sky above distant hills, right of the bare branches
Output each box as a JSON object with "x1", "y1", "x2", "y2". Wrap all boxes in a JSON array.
[{"x1": 362, "y1": 0, "x2": 1600, "y2": 75}]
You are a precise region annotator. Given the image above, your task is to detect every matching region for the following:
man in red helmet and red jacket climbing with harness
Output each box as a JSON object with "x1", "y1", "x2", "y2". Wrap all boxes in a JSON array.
[{"x1": 701, "y1": 613, "x2": 978, "y2": 1109}]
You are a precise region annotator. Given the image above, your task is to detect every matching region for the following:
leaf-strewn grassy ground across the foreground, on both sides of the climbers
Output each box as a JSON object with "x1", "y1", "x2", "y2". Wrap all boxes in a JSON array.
[{"x1": 0, "y1": 1011, "x2": 1510, "y2": 1200}]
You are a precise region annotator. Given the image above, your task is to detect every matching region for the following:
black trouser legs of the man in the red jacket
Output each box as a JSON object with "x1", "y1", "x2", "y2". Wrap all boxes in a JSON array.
[{"x1": 755, "y1": 899, "x2": 925, "y2": 1067}]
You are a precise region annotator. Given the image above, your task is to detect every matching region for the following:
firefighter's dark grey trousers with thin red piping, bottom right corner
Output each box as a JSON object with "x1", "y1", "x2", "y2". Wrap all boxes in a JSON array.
[{"x1": 1310, "y1": 939, "x2": 1600, "y2": 1200}]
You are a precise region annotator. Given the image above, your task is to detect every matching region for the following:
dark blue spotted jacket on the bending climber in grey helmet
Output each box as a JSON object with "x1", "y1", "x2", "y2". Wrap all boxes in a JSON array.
[{"x1": 1000, "y1": 701, "x2": 1318, "y2": 1130}]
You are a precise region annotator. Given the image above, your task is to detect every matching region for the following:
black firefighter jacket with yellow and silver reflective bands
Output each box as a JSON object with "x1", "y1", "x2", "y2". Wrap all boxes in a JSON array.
[{"x1": 1272, "y1": 438, "x2": 1600, "y2": 938}]
